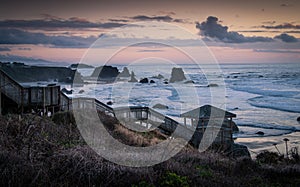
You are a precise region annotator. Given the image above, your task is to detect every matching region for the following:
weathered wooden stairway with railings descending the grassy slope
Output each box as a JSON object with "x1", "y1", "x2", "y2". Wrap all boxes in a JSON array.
[{"x1": 0, "y1": 69, "x2": 235, "y2": 146}]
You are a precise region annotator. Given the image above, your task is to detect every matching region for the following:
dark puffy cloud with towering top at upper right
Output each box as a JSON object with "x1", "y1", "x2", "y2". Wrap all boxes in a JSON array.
[{"x1": 196, "y1": 16, "x2": 273, "y2": 43}]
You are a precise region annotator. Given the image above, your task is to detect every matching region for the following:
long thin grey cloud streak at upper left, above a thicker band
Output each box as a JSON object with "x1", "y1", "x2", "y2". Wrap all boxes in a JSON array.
[{"x1": 0, "y1": 17, "x2": 125, "y2": 29}]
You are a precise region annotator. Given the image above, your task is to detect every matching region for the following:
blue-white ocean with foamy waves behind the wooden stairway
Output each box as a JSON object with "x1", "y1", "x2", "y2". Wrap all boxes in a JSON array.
[{"x1": 72, "y1": 63, "x2": 300, "y2": 154}]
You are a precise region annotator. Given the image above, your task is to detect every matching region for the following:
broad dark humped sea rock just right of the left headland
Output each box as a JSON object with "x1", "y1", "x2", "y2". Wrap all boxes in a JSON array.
[{"x1": 91, "y1": 66, "x2": 120, "y2": 80}]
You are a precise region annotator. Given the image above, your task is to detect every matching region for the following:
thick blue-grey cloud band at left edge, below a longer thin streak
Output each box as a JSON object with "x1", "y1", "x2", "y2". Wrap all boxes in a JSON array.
[{"x1": 0, "y1": 29, "x2": 97, "y2": 47}]
